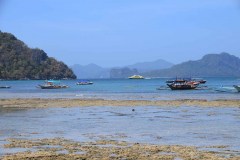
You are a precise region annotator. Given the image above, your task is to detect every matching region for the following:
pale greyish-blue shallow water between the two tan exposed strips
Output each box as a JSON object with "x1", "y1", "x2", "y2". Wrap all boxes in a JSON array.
[{"x1": 0, "y1": 106, "x2": 240, "y2": 155}]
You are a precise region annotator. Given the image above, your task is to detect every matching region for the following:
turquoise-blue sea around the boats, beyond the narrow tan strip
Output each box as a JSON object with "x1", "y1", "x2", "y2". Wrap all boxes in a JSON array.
[{"x1": 0, "y1": 78, "x2": 240, "y2": 100}]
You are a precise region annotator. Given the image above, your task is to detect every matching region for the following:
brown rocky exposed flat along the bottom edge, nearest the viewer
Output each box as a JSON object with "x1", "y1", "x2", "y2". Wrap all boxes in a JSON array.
[{"x1": 3, "y1": 138, "x2": 240, "y2": 160}]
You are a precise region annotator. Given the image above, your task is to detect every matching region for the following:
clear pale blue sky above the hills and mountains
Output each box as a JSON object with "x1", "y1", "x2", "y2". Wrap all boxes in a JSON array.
[{"x1": 0, "y1": 0, "x2": 240, "y2": 67}]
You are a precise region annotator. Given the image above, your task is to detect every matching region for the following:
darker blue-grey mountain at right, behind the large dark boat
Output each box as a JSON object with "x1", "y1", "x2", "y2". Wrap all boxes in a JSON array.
[{"x1": 144, "y1": 53, "x2": 240, "y2": 77}]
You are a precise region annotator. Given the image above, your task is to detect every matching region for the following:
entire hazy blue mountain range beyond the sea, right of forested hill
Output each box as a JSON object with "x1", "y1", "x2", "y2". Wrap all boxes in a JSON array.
[{"x1": 72, "y1": 53, "x2": 240, "y2": 78}]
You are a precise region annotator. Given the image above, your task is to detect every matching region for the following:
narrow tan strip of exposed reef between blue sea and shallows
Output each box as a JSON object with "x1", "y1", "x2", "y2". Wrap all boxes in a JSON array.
[{"x1": 0, "y1": 98, "x2": 240, "y2": 108}]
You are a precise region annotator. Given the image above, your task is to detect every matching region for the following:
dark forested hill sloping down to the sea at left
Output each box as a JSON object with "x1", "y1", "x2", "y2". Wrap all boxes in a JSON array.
[{"x1": 0, "y1": 31, "x2": 76, "y2": 80}]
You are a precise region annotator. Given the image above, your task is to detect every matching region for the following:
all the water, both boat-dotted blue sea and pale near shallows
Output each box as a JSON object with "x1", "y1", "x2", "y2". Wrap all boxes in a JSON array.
[{"x1": 0, "y1": 78, "x2": 240, "y2": 156}]
